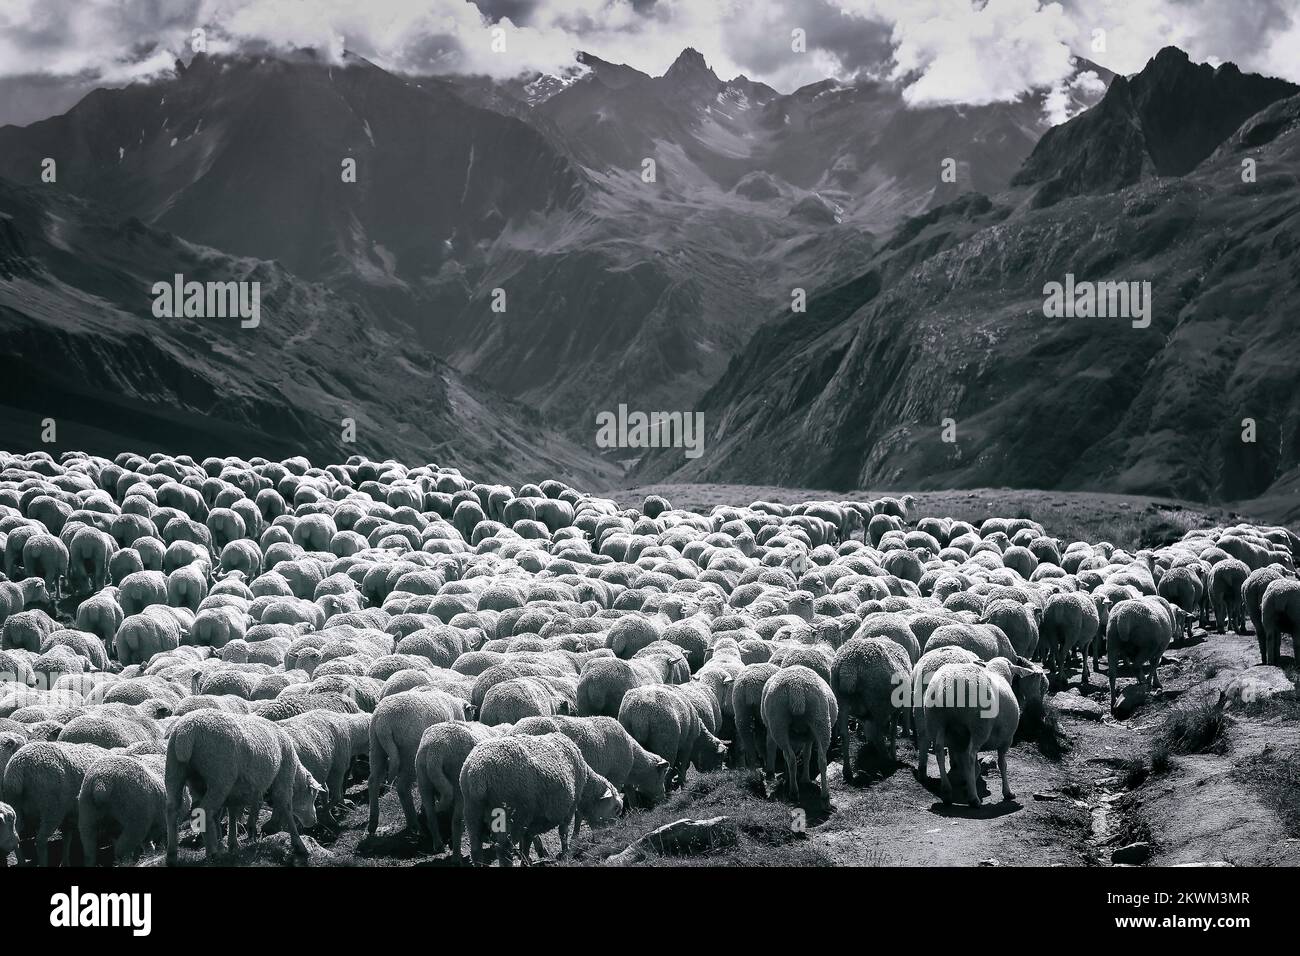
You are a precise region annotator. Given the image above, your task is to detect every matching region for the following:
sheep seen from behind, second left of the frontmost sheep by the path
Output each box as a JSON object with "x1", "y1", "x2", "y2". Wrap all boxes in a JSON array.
[{"x1": 831, "y1": 637, "x2": 911, "y2": 782}]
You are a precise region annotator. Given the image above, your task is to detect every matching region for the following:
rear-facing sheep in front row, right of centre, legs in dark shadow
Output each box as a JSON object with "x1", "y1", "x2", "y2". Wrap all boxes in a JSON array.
[{"x1": 761, "y1": 665, "x2": 839, "y2": 804}]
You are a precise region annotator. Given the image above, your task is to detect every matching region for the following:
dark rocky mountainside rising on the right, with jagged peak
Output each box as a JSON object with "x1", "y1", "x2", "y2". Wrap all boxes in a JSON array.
[{"x1": 637, "y1": 51, "x2": 1300, "y2": 499}]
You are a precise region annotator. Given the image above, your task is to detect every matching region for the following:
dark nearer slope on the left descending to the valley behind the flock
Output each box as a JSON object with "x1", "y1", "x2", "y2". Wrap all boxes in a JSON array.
[{"x1": 0, "y1": 172, "x2": 606, "y2": 479}]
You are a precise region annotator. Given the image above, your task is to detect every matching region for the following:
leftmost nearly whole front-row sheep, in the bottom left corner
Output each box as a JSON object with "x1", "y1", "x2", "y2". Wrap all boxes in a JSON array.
[{"x1": 0, "y1": 741, "x2": 108, "y2": 866}]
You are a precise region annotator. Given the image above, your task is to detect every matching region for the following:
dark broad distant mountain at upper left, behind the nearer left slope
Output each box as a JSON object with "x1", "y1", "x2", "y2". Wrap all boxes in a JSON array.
[{"x1": 0, "y1": 47, "x2": 584, "y2": 295}]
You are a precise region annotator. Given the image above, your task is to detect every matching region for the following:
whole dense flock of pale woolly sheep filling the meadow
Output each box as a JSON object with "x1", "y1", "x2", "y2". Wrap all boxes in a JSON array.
[{"x1": 0, "y1": 453, "x2": 1300, "y2": 865}]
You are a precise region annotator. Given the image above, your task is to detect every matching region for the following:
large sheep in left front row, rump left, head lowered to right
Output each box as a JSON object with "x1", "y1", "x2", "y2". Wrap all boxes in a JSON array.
[{"x1": 164, "y1": 709, "x2": 324, "y2": 866}]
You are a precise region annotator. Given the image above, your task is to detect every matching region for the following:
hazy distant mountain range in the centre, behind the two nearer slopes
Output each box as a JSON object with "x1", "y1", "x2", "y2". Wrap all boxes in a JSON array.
[{"x1": 0, "y1": 49, "x2": 1109, "y2": 463}]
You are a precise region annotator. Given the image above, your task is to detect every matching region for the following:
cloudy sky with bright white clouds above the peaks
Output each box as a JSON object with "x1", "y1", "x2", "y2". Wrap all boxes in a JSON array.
[{"x1": 0, "y1": 0, "x2": 1300, "y2": 125}]
